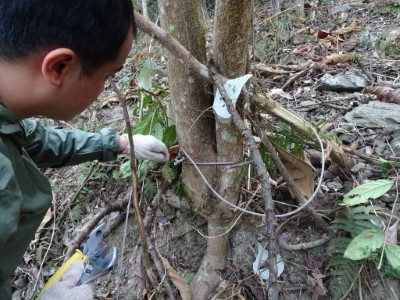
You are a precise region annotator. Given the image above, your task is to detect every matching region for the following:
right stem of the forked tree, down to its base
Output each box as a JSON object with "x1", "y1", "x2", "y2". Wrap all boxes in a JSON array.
[{"x1": 191, "y1": 0, "x2": 252, "y2": 300}]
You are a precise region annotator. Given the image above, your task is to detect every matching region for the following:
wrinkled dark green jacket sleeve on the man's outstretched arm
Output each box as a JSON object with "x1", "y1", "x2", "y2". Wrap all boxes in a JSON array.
[{"x1": 21, "y1": 120, "x2": 119, "y2": 168}]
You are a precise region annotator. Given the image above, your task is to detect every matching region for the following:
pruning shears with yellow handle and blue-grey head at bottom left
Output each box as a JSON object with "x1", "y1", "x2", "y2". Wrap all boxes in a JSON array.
[{"x1": 39, "y1": 223, "x2": 117, "y2": 298}]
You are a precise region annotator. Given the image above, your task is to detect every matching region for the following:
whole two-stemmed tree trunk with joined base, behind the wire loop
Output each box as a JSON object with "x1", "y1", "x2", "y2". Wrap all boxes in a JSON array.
[{"x1": 159, "y1": 0, "x2": 252, "y2": 300}]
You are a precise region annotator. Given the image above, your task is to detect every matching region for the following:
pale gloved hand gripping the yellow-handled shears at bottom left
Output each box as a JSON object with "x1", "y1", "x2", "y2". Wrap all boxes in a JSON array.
[{"x1": 40, "y1": 260, "x2": 94, "y2": 300}]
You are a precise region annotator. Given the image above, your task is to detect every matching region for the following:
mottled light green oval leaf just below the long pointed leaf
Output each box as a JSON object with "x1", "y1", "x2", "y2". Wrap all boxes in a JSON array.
[{"x1": 344, "y1": 229, "x2": 385, "y2": 260}]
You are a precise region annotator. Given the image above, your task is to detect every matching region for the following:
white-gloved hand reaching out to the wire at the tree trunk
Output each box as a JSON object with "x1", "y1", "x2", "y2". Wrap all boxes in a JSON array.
[{"x1": 121, "y1": 134, "x2": 169, "y2": 162}]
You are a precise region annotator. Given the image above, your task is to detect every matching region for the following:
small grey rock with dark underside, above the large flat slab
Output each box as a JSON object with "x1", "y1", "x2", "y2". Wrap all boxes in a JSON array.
[{"x1": 317, "y1": 71, "x2": 368, "y2": 92}]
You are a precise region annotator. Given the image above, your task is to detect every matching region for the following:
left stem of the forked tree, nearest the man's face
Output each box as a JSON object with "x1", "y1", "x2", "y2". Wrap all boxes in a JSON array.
[{"x1": 158, "y1": 0, "x2": 216, "y2": 218}]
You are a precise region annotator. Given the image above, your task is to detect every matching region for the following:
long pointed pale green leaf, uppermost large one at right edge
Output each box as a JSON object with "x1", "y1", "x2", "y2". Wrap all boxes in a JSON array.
[{"x1": 343, "y1": 179, "x2": 393, "y2": 206}]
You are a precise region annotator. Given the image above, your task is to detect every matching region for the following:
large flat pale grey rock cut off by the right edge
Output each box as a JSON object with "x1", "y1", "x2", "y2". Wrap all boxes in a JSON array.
[{"x1": 345, "y1": 101, "x2": 400, "y2": 129}]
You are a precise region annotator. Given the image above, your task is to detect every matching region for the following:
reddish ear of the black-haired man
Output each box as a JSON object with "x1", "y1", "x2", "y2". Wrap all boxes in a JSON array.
[{"x1": 42, "y1": 48, "x2": 81, "y2": 87}]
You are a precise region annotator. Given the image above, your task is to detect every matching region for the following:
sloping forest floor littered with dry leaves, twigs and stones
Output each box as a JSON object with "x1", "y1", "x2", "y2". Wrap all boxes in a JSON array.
[{"x1": 13, "y1": 1, "x2": 400, "y2": 300}]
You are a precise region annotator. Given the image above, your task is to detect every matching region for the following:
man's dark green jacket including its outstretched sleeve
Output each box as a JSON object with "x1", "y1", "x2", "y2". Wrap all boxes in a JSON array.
[{"x1": 0, "y1": 102, "x2": 119, "y2": 300}]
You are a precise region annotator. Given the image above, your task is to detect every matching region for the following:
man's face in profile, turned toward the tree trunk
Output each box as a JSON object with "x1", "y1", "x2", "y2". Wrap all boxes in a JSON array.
[{"x1": 53, "y1": 33, "x2": 133, "y2": 120}]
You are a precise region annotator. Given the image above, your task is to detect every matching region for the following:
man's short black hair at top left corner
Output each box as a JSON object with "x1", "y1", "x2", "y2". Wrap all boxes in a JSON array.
[{"x1": 0, "y1": 0, "x2": 136, "y2": 76}]
